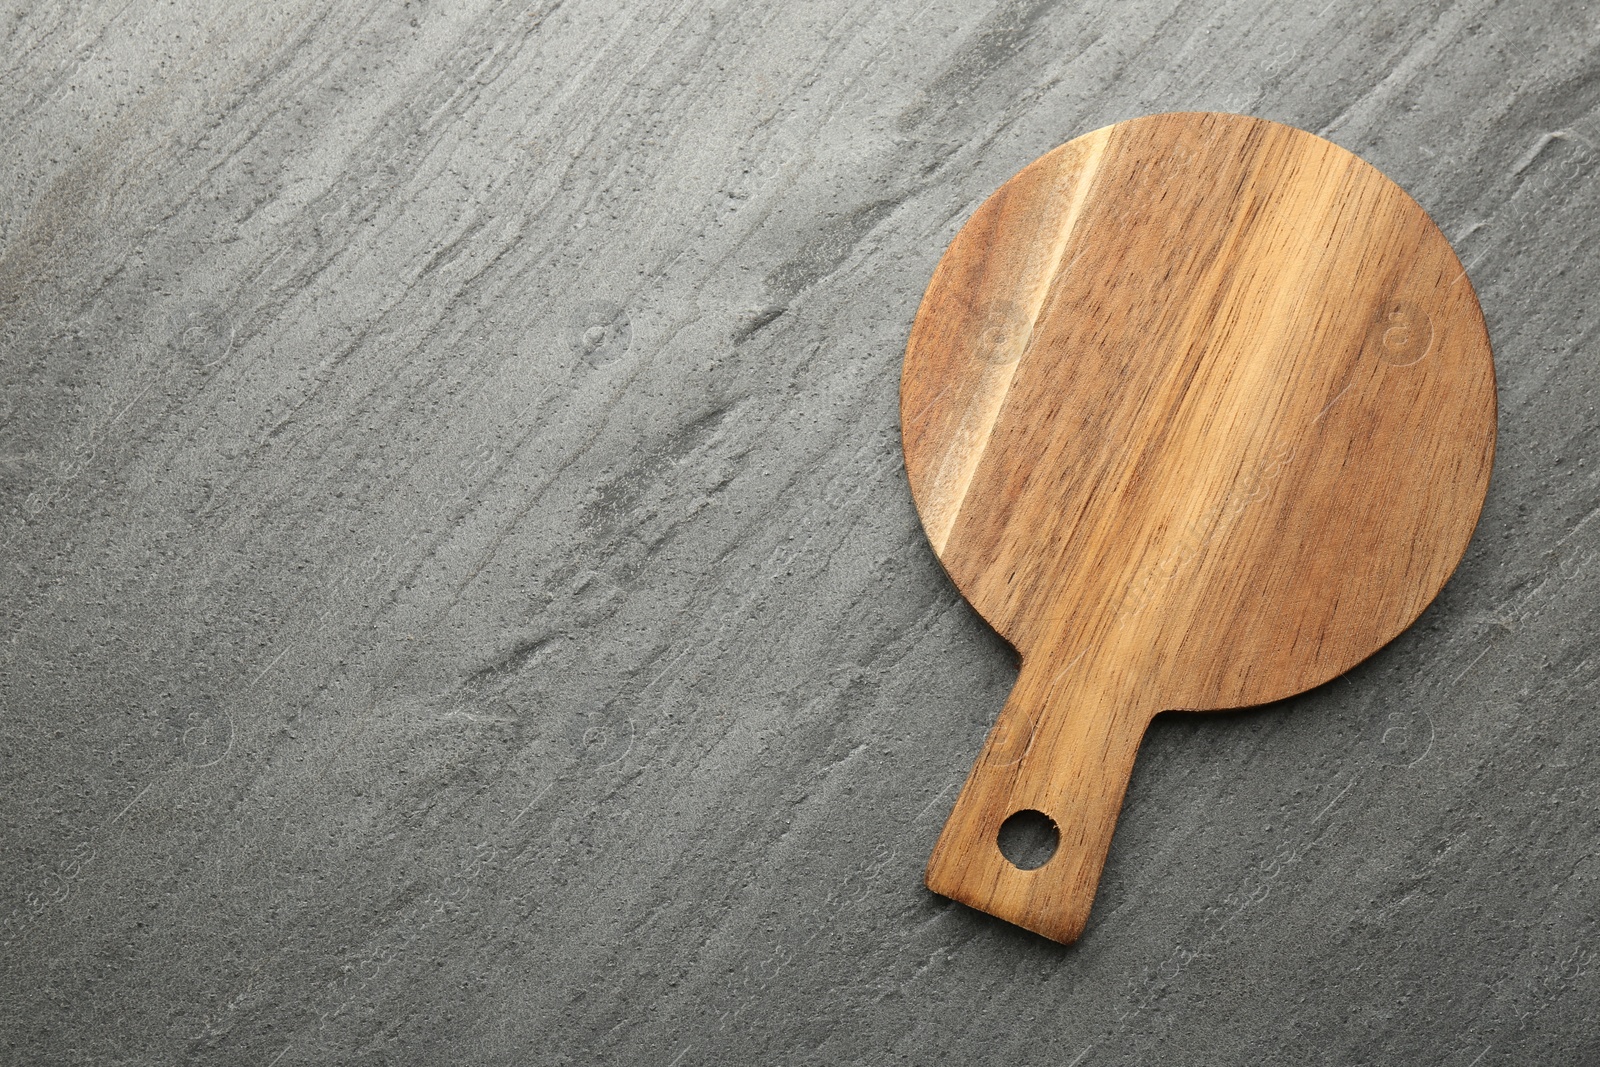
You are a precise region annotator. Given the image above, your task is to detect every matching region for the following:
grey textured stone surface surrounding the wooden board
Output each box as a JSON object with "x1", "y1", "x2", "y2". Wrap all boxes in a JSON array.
[{"x1": 0, "y1": 0, "x2": 1600, "y2": 1067}]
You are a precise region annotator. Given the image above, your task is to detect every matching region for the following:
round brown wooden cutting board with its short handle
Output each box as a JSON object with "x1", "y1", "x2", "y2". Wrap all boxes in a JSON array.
[{"x1": 901, "y1": 112, "x2": 1496, "y2": 942}]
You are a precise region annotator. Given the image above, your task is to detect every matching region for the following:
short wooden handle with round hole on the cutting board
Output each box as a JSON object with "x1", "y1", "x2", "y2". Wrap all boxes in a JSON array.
[{"x1": 926, "y1": 657, "x2": 1155, "y2": 944}]
